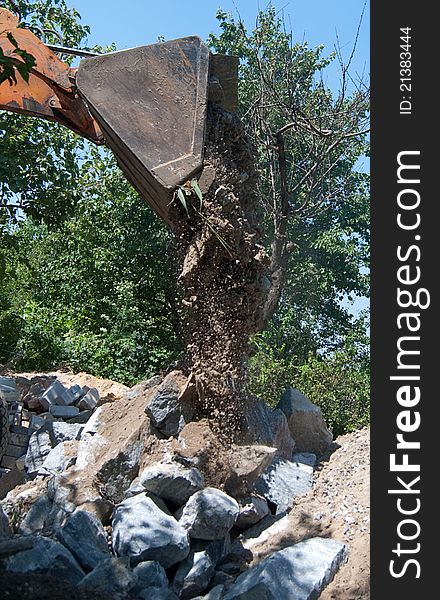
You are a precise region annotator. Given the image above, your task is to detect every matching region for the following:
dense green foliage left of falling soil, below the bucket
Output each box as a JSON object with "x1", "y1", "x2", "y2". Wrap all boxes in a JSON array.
[{"x1": 0, "y1": 150, "x2": 180, "y2": 383}]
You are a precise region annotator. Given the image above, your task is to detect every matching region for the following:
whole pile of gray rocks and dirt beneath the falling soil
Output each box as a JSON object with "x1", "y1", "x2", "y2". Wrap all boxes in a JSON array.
[{"x1": 0, "y1": 371, "x2": 347, "y2": 600}]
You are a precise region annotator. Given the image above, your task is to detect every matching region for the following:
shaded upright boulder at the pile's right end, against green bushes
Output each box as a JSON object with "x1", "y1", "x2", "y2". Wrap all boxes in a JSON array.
[{"x1": 277, "y1": 387, "x2": 333, "y2": 455}]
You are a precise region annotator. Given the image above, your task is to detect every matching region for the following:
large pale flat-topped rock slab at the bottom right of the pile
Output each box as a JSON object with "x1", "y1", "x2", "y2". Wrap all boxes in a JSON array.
[{"x1": 224, "y1": 538, "x2": 347, "y2": 600}]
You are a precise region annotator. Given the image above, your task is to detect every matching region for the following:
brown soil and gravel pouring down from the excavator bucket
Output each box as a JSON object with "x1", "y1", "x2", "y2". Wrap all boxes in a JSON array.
[{"x1": 176, "y1": 106, "x2": 270, "y2": 437}]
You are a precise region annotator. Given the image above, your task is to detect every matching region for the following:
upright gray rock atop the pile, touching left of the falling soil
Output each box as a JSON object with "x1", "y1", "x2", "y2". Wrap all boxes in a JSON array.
[{"x1": 145, "y1": 371, "x2": 193, "y2": 437}]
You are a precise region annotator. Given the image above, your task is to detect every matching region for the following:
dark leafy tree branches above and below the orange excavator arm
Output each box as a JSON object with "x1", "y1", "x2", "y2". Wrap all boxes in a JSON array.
[{"x1": 0, "y1": 0, "x2": 108, "y2": 227}]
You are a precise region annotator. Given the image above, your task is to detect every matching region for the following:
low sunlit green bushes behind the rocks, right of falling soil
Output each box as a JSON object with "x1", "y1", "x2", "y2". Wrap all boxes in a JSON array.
[{"x1": 250, "y1": 321, "x2": 370, "y2": 436}]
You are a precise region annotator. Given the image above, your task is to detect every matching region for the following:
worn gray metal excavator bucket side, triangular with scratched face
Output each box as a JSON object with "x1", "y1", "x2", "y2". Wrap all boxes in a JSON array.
[{"x1": 76, "y1": 37, "x2": 209, "y2": 225}]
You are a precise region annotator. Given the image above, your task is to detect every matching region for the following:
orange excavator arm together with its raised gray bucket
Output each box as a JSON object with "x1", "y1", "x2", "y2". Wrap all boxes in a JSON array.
[{"x1": 0, "y1": 8, "x2": 238, "y2": 229}]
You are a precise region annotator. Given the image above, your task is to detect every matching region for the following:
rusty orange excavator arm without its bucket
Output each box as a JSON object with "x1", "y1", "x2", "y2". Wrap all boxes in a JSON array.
[{"x1": 0, "y1": 8, "x2": 102, "y2": 143}]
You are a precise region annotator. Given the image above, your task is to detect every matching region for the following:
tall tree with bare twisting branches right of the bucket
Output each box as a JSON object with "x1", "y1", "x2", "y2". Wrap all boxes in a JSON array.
[{"x1": 209, "y1": 6, "x2": 369, "y2": 358}]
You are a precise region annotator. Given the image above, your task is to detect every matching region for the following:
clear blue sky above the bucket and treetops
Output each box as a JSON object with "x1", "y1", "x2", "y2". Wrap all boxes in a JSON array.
[{"x1": 67, "y1": 0, "x2": 370, "y2": 86}]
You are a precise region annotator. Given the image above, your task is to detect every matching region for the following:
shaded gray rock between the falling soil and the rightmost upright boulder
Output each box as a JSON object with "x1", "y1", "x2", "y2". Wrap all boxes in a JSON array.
[{"x1": 242, "y1": 398, "x2": 295, "y2": 459}]
